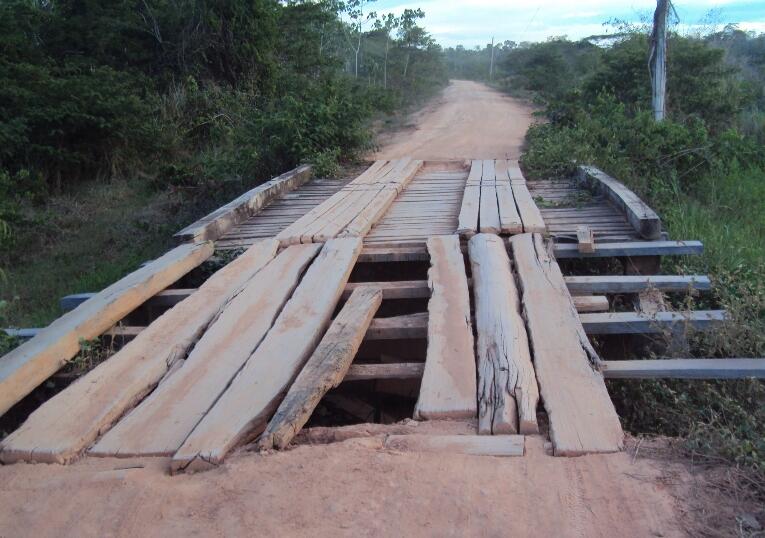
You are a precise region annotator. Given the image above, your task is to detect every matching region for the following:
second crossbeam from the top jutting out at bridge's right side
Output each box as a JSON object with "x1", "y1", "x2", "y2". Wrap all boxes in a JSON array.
[{"x1": 565, "y1": 275, "x2": 712, "y2": 294}]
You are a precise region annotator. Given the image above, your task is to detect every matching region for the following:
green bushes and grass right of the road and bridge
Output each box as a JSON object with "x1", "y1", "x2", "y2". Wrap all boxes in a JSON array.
[{"x1": 445, "y1": 22, "x2": 765, "y2": 468}]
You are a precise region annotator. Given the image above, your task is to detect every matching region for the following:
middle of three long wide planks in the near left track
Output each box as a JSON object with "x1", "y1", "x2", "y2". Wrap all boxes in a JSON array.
[{"x1": 89, "y1": 245, "x2": 320, "y2": 457}]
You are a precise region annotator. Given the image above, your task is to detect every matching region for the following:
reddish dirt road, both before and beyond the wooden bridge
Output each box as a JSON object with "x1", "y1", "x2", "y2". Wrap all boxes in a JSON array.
[{"x1": 0, "y1": 82, "x2": 765, "y2": 538}]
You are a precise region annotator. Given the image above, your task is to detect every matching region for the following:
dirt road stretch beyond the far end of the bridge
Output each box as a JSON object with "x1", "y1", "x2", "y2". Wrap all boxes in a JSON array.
[{"x1": 373, "y1": 80, "x2": 533, "y2": 160}]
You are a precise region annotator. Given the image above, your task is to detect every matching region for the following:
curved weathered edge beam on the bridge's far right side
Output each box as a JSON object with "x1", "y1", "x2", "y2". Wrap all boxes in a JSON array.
[{"x1": 577, "y1": 166, "x2": 661, "y2": 239}]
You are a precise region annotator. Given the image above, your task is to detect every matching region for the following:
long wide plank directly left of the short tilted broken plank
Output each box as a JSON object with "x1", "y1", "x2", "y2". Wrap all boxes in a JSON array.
[{"x1": 171, "y1": 238, "x2": 361, "y2": 471}]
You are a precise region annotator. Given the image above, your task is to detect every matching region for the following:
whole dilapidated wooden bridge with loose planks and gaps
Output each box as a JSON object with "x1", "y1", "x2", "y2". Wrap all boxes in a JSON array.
[{"x1": 0, "y1": 159, "x2": 765, "y2": 471}]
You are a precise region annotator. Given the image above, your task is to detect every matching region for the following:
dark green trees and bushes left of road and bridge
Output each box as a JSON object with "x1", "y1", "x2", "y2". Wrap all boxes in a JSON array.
[{"x1": 0, "y1": 0, "x2": 446, "y2": 326}]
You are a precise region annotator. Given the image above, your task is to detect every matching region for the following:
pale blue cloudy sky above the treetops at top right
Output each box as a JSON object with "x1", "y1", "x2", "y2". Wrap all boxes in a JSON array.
[{"x1": 368, "y1": 0, "x2": 765, "y2": 47}]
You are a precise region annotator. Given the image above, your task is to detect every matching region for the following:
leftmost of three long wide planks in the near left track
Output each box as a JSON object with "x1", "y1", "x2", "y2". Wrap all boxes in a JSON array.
[{"x1": 0, "y1": 239, "x2": 279, "y2": 463}]
